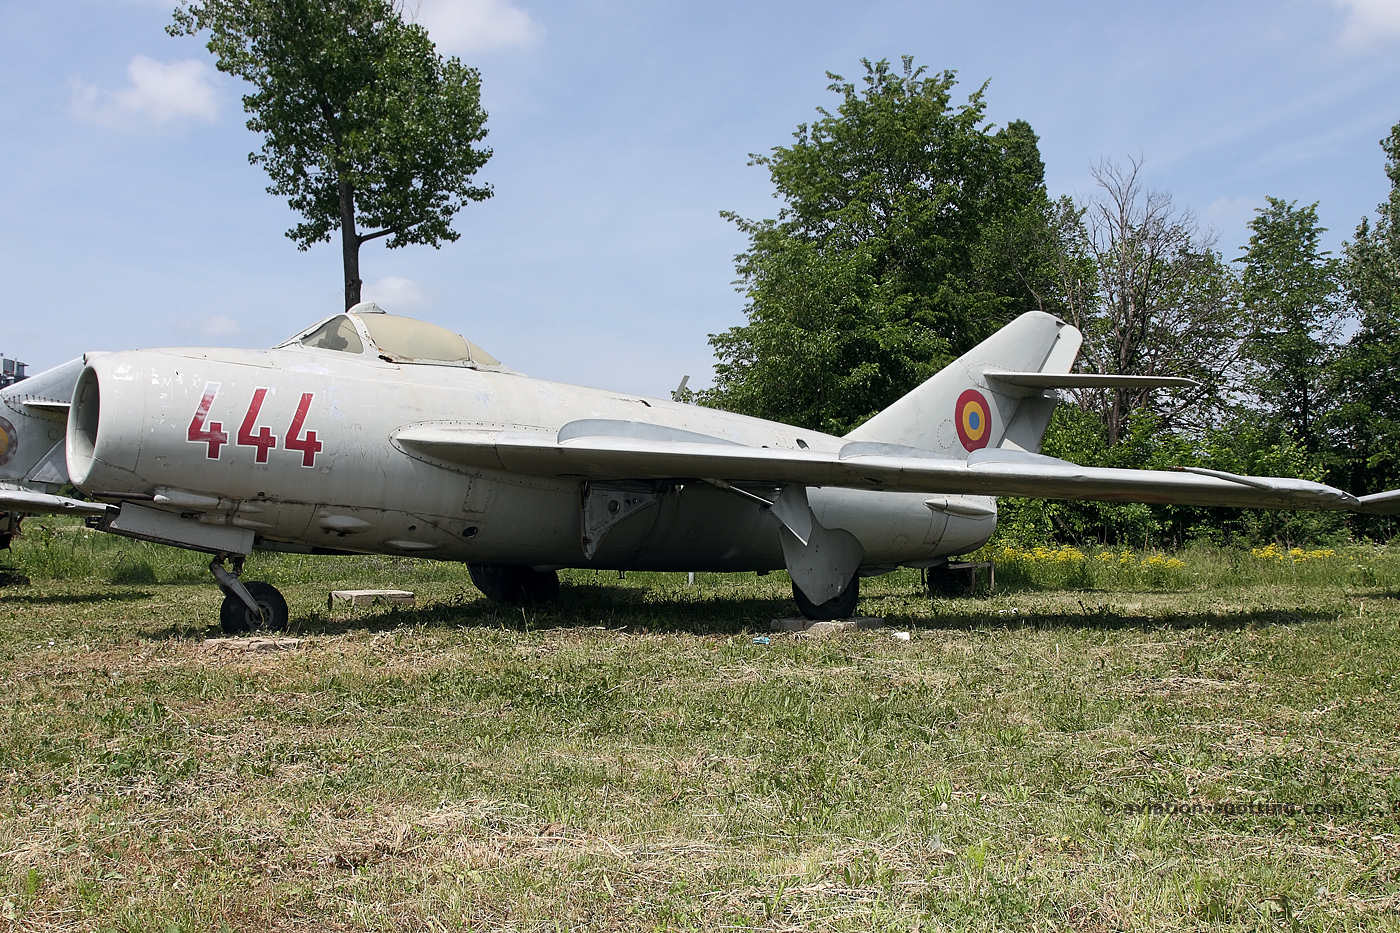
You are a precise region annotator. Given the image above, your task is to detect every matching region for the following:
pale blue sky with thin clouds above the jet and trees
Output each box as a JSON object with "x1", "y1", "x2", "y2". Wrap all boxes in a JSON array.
[{"x1": 0, "y1": 0, "x2": 1400, "y2": 395}]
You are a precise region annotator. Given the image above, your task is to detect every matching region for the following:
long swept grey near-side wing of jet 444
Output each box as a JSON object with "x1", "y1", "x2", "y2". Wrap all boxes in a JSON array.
[{"x1": 393, "y1": 419, "x2": 1366, "y2": 511}]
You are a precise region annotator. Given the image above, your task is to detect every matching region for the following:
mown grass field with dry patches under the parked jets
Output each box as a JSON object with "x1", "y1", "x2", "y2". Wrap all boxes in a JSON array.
[{"x1": 0, "y1": 520, "x2": 1400, "y2": 933}]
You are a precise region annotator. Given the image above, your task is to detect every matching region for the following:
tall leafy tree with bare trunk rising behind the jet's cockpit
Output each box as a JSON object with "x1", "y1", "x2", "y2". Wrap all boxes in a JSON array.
[{"x1": 167, "y1": 0, "x2": 491, "y2": 308}]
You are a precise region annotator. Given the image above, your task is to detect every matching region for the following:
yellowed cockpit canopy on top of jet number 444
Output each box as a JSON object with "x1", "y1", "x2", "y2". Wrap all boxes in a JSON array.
[{"x1": 281, "y1": 301, "x2": 503, "y2": 368}]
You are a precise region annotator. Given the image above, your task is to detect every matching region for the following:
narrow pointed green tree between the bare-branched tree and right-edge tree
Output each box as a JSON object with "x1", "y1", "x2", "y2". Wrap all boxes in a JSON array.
[{"x1": 1235, "y1": 198, "x2": 1344, "y2": 451}]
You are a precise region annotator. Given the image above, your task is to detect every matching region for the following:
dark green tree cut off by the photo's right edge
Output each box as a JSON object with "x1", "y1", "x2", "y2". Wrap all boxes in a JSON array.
[{"x1": 1333, "y1": 123, "x2": 1400, "y2": 493}]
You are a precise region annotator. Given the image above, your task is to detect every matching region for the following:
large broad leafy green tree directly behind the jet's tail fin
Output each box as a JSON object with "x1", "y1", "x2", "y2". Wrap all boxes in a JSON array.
[{"x1": 703, "y1": 57, "x2": 1054, "y2": 433}]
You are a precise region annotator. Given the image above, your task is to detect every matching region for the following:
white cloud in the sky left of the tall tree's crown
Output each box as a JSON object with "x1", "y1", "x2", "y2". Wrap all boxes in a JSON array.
[{"x1": 73, "y1": 55, "x2": 218, "y2": 126}]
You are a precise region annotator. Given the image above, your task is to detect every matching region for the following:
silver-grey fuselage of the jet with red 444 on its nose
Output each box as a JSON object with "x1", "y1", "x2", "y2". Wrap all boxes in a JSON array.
[{"x1": 67, "y1": 337, "x2": 995, "y2": 572}]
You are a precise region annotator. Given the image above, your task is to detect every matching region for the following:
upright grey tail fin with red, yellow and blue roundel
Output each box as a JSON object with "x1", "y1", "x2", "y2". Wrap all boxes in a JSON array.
[{"x1": 846, "y1": 311, "x2": 1082, "y2": 459}]
